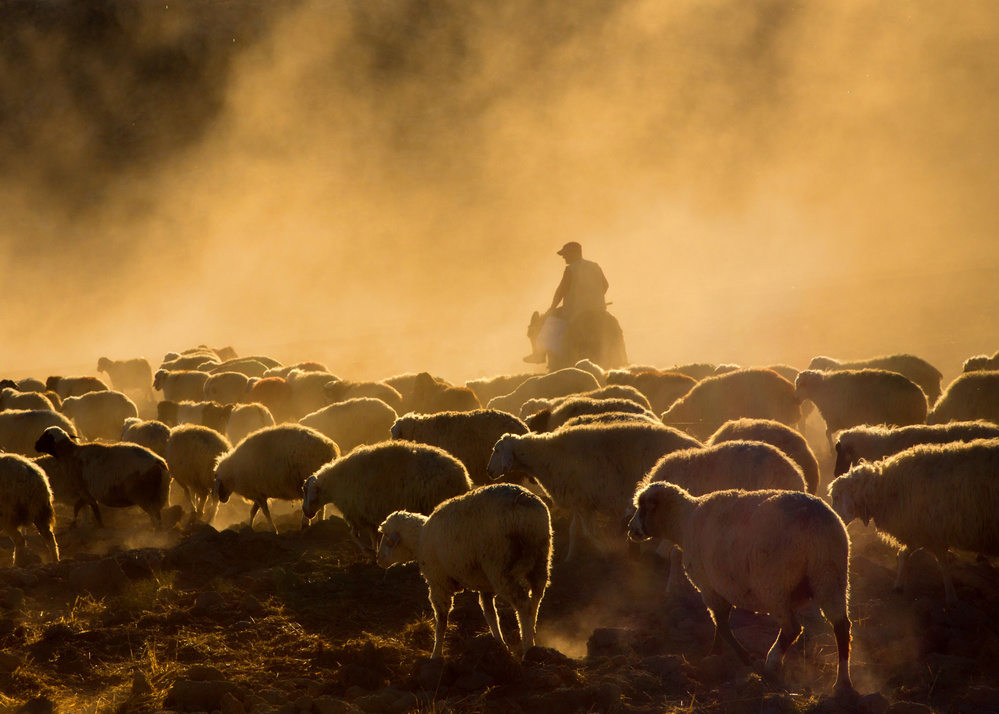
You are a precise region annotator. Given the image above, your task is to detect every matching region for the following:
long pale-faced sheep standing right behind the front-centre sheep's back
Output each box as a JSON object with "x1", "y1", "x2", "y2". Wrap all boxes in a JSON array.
[{"x1": 486, "y1": 423, "x2": 701, "y2": 561}]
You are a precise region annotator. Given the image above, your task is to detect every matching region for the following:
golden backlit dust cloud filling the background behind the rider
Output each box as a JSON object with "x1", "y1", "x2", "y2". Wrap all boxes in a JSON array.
[{"x1": 0, "y1": 0, "x2": 999, "y2": 382}]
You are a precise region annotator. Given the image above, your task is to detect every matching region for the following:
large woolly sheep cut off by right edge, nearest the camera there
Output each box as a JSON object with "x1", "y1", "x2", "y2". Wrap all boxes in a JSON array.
[{"x1": 829, "y1": 439, "x2": 999, "y2": 605}]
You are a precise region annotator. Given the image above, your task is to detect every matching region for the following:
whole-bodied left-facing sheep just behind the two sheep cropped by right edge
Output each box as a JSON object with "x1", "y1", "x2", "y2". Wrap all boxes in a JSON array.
[{"x1": 794, "y1": 369, "x2": 927, "y2": 444}]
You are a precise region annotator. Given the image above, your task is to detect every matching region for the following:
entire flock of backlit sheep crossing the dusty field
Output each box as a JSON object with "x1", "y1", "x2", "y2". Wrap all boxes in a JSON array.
[{"x1": 0, "y1": 347, "x2": 999, "y2": 692}]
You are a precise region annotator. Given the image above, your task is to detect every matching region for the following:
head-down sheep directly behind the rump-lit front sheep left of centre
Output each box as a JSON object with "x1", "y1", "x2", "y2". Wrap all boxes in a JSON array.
[{"x1": 302, "y1": 441, "x2": 472, "y2": 555}]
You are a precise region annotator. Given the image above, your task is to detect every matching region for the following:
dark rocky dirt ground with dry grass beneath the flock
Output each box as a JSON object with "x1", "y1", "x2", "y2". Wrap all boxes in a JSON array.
[{"x1": 0, "y1": 428, "x2": 999, "y2": 714}]
